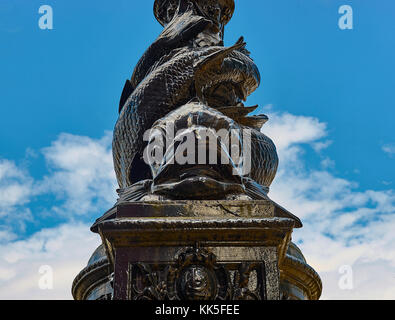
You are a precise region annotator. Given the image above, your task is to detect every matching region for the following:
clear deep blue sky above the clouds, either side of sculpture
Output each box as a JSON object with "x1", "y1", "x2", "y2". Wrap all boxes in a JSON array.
[{"x1": 0, "y1": 0, "x2": 395, "y2": 192}]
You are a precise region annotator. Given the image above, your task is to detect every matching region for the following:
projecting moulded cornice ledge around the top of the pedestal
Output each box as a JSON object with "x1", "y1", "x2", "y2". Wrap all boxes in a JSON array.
[{"x1": 98, "y1": 218, "x2": 295, "y2": 246}]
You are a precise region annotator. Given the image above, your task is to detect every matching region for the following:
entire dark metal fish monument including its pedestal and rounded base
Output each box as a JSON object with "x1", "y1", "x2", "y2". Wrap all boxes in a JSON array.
[{"x1": 72, "y1": 0, "x2": 322, "y2": 300}]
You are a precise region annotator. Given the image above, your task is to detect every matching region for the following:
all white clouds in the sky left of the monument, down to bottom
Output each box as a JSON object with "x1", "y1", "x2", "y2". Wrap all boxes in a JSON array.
[{"x1": 0, "y1": 133, "x2": 116, "y2": 299}]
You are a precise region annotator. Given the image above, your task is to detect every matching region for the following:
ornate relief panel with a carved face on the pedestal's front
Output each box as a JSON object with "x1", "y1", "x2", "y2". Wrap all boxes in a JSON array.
[{"x1": 129, "y1": 248, "x2": 266, "y2": 301}]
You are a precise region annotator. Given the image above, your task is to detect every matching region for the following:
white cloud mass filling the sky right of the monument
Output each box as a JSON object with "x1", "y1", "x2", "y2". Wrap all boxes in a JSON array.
[{"x1": 265, "y1": 110, "x2": 395, "y2": 299}]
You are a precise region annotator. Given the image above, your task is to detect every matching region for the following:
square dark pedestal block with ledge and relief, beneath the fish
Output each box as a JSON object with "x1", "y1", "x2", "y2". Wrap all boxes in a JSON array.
[{"x1": 82, "y1": 201, "x2": 308, "y2": 300}]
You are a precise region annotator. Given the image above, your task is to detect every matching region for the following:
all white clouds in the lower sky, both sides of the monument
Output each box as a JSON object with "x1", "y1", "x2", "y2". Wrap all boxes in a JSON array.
[{"x1": 0, "y1": 110, "x2": 395, "y2": 299}]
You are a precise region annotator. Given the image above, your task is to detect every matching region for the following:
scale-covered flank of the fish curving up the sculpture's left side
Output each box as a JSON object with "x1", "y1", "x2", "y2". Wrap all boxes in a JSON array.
[{"x1": 113, "y1": 42, "x2": 248, "y2": 188}]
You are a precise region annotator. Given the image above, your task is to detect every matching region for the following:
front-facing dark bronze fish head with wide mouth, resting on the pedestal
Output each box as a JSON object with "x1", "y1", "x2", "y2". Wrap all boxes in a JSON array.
[{"x1": 150, "y1": 101, "x2": 279, "y2": 200}]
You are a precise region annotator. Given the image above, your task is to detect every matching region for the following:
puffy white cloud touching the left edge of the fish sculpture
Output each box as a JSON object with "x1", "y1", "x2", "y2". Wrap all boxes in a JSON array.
[{"x1": 38, "y1": 133, "x2": 117, "y2": 215}]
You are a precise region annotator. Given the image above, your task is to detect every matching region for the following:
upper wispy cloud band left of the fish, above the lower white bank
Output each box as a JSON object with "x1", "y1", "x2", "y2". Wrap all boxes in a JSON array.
[{"x1": 0, "y1": 132, "x2": 117, "y2": 232}]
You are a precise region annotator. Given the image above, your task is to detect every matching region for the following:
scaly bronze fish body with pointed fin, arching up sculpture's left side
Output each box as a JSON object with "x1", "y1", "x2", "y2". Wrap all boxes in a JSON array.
[{"x1": 113, "y1": 38, "x2": 254, "y2": 188}]
